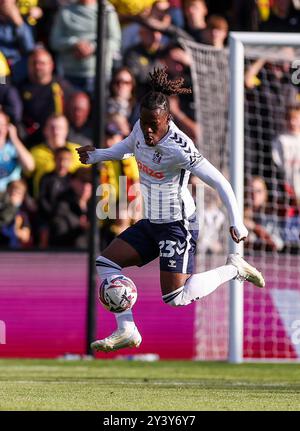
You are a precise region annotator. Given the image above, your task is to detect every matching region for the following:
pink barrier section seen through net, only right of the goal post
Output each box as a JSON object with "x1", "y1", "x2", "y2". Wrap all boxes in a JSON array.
[{"x1": 244, "y1": 254, "x2": 300, "y2": 360}]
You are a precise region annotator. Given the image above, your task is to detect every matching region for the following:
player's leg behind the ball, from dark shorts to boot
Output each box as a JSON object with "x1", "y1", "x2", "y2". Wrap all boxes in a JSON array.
[{"x1": 92, "y1": 220, "x2": 159, "y2": 352}]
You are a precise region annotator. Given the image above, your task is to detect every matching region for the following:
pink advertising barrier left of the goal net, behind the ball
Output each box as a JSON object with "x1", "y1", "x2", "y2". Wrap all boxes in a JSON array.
[{"x1": 0, "y1": 252, "x2": 194, "y2": 359}]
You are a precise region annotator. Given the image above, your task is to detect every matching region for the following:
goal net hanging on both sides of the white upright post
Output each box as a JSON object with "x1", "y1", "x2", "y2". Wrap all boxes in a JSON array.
[{"x1": 182, "y1": 34, "x2": 300, "y2": 360}]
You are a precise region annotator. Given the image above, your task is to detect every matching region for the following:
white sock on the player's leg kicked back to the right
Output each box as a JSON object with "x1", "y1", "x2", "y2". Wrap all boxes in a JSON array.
[{"x1": 162, "y1": 265, "x2": 237, "y2": 307}]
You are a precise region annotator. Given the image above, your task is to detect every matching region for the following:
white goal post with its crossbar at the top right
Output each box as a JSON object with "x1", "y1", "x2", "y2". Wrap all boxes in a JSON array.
[{"x1": 228, "y1": 32, "x2": 300, "y2": 363}]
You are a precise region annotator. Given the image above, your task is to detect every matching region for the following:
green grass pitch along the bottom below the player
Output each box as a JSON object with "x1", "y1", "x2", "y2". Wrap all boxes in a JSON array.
[{"x1": 0, "y1": 359, "x2": 300, "y2": 411}]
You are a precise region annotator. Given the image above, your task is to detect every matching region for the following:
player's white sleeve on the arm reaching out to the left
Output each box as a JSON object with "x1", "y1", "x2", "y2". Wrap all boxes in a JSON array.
[{"x1": 87, "y1": 131, "x2": 135, "y2": 164}]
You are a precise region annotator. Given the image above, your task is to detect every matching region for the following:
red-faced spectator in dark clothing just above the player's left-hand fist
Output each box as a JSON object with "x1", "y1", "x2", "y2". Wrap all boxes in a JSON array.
[{"x1": 66, "y1": 92, "x2": 93, "y2": 145}]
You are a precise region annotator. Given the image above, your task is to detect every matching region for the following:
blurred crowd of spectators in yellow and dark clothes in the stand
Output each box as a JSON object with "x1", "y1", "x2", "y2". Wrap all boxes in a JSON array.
[{"x1": 0, "y1": 0, "x2": 300, "y2": 252}]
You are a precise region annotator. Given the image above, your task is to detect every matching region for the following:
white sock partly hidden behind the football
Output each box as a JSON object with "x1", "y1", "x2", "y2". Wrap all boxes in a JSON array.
[{"x1": 96, "y1": 256, "x2": 135, "y2": 329}]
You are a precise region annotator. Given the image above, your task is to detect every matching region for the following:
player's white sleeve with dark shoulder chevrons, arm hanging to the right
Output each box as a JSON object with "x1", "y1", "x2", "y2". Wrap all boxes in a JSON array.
[{"x1": 178, "y1": 142, "x2": 248, "y2": 239}]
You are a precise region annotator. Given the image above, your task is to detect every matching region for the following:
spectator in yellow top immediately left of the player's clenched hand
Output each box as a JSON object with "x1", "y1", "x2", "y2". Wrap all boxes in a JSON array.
[{"x1": 30, "y1": 114, "x2": 82, "y2": 198}]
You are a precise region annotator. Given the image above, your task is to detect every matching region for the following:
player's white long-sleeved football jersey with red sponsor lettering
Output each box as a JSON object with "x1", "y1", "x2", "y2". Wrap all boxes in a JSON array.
[{"x1": 87, "y1": 121, "x2": 248, "y2": 238}]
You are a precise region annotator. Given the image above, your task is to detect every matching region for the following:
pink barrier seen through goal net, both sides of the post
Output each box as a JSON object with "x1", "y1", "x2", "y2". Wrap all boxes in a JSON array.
[{"x1": 195, "y1": 254, "x2": 300, "y2": 361}]
